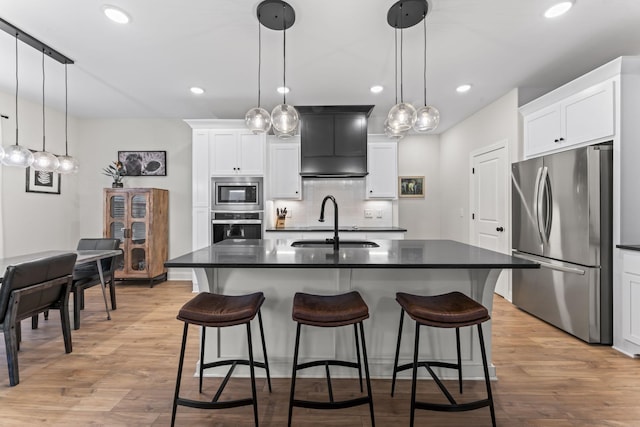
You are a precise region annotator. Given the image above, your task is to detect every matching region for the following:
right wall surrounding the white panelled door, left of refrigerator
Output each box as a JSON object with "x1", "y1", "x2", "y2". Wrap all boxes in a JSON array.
[{"x1": 440, "y1": 89, "x2": 521, "y2": 243}]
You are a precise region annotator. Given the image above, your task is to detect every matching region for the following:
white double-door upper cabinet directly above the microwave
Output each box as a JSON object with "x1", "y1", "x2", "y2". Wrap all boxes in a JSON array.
[{"x1": 209, "y1": 129, "x2": 265, "y2": 176}]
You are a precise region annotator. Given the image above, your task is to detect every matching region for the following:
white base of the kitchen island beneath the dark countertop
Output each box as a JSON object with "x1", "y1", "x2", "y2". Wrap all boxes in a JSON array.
[{"x1": 200, "y1": 268, "x2": 500, "y2": 379}]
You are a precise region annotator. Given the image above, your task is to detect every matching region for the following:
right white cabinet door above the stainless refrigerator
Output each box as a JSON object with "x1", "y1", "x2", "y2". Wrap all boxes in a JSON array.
[{"x1": 562, "y1": 81, "x2": 615, "y2": 145}]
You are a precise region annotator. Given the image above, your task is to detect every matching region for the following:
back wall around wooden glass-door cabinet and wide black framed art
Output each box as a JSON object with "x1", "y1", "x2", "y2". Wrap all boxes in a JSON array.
[{"x1": 78, "y1": 119, "x2": 191, "y2": 264}]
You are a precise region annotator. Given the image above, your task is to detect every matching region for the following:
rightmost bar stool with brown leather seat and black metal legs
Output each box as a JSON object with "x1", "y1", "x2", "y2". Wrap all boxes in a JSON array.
[{"x1": 391, "y1": 292, "x2": 496, "y2": 427}]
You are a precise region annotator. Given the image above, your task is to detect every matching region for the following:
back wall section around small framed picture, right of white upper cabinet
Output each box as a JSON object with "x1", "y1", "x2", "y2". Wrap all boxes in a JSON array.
[{"x1": 398, "y1": 135, "x2": 444, "y2": 239}]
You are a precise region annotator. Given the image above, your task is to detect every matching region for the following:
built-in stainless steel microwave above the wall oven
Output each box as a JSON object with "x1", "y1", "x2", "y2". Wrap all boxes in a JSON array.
[{"x1": 211, "y1": 176, "x2": 264, "y2": 211}]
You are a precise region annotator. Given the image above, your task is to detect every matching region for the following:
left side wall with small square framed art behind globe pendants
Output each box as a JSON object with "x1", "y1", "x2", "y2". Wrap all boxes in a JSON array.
[{"x1": 0, "y1": 92, "x2": 79, "y2": 256}]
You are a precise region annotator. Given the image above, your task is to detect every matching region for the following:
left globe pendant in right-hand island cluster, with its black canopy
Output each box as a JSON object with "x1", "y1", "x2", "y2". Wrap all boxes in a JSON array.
[{"x1": 387, "y1": 0, "x2": 426, "y2": 132}]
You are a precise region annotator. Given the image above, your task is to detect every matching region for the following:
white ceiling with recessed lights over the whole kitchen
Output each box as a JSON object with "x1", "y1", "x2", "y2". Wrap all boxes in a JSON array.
[{"x1": 0, "y1": 0, "x2": 640, "y2": 133}]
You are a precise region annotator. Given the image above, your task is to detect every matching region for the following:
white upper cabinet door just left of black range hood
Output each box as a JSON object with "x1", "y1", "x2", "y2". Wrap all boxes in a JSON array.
[{"x1": 269, "y1": 142, "x2": 302, "y2": 200}]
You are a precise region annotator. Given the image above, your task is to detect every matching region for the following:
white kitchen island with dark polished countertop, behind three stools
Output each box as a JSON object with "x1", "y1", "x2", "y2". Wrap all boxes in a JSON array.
[{"x1": 165, "y1": 240, "x2": 539, "y2": 378}]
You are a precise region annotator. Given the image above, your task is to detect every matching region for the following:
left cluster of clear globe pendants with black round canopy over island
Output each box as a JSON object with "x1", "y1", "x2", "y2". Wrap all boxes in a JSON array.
[{"x1": 245, "y1": 0, "x2": 300, "y2": 138}]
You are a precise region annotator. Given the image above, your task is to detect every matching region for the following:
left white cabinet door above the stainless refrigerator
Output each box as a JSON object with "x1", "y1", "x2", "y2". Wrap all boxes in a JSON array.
[{"x1": 524, "y1": 104, "x2": 563, "y2": 157}]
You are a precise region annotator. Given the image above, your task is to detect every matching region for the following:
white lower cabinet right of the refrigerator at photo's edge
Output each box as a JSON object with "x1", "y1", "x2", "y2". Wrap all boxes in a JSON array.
[{"x1": 621, "y1": 251, "x2": 640, "y2": 346}]
